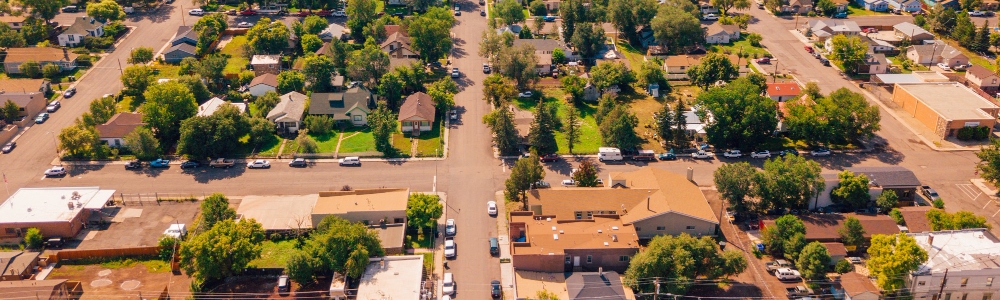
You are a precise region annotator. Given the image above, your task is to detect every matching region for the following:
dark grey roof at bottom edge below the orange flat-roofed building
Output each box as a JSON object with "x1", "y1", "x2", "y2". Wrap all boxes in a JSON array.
[{"x1": 566, "y1": 271, "x2": 628, "y2": 300}]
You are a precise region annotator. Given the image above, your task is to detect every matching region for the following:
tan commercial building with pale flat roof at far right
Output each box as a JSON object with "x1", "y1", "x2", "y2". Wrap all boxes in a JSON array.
[{"x1": 892, "y1": 82, "x2": 1000, "y2": 138}]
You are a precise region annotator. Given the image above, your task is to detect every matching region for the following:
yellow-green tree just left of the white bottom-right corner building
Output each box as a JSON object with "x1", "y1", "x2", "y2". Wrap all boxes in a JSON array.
[{"x1": 867, "y1": 233, "x2": 927, "y2": 291}]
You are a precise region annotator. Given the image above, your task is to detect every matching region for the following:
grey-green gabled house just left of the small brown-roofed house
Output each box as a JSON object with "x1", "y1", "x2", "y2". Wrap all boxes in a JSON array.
[{"x1": 309, "y1": 85, "x2": 375, "y2": 126}]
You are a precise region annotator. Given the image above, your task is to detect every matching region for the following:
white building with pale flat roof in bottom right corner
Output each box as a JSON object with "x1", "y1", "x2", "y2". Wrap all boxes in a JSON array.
[{"x1": 905, "y1": 229, "x2": 1000, "y2": 300}]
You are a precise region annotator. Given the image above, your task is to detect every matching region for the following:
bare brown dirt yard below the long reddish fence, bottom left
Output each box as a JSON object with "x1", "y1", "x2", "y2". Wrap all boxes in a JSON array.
[{"x1": 47, "y1": 263, "x2": 191, "y2": 299}]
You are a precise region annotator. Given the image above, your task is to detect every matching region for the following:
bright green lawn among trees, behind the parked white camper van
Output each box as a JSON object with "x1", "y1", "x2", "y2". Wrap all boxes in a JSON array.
[{"x1": 515, "y1": 89, "x2": 601, "y2": 154}]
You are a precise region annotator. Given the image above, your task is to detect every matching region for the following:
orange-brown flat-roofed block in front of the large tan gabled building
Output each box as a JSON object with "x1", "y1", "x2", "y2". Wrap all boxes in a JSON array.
[{"x1": 508, "y1": 211, "x2": 639, "y2": 273}]
